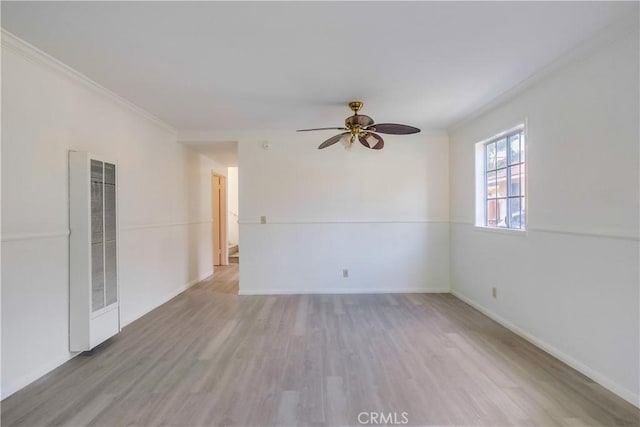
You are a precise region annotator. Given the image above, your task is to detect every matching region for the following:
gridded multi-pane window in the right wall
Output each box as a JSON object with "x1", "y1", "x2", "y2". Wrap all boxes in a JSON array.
[{"x1": 476, "y1": 126, "x2": 526, "y2": 230}]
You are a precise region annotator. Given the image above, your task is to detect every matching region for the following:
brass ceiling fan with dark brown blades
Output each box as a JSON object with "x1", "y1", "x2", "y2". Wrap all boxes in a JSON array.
[{"x1": 297, "y1": 101, "x2": 420, "y2": 150}]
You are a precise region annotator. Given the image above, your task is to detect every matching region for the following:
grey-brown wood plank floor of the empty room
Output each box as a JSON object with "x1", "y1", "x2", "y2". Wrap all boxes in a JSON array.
[{"x1": 1, "y1": 265, "x2": 640, "y2": 426}]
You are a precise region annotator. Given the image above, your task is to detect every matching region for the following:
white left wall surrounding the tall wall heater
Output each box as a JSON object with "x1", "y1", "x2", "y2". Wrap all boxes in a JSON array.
[{"x1": 2, "y1": 34, "x2": 226, "y2": 397}]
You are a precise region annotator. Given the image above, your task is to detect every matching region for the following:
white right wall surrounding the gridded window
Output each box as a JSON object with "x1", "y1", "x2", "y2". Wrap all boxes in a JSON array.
[{"x1": 450, "y1": 23, "x2": 640, "y2": 405}]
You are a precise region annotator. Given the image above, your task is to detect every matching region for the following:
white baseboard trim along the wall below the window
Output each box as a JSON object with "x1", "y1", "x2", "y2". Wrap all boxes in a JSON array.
[{"x1": 451, "y1": 290, "x2": 640, "y2": 408}]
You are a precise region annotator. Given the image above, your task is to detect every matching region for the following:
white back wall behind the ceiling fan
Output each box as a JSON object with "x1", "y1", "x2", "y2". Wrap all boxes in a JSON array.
[{"x1": 238, "y1": 132, "x2": 449, "y2": 294}]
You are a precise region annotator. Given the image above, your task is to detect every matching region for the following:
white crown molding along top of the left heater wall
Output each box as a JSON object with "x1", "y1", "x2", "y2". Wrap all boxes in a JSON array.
[{"x1": 1, "y1": 28, "x2": 178, "y2": 135}]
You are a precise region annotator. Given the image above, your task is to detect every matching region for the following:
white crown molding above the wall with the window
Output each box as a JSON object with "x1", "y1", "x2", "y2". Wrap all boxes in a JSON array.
[{"x1": 447, "y1": 16, "x2": 638, "y2": 134}]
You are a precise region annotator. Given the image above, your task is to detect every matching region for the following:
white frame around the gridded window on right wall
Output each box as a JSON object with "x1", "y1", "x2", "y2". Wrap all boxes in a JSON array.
[{"x1": 475, "y1": 120, "x2": 529, "y2": 235}]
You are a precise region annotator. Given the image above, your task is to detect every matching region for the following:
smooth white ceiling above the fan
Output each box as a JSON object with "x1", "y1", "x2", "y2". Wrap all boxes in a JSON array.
[{"x1": 1, "y1": 1, "x2": 638, "y2": 130}]
